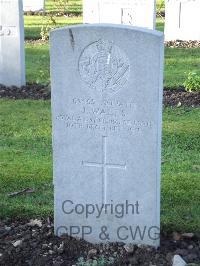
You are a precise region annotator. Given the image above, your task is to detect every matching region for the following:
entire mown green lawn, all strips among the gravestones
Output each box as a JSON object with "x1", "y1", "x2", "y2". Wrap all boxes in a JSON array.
[{"x1": 0, "y1": 0, "x2": 200, "y2": 235}]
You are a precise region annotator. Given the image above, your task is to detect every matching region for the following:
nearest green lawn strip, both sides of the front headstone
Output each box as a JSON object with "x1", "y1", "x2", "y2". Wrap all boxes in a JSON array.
[{"x1": 0, "y1": 100, "x2": 200, "y2": 231}]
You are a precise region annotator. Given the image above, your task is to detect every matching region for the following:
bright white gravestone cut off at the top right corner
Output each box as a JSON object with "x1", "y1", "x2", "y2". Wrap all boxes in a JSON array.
[{"x1": 165, "y1": 0, "x2": 200, "y2": 41}]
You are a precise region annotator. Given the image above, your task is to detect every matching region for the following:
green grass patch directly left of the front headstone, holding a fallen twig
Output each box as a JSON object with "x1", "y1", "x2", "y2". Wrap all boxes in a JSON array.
[{"x1": 0, "y1": 100, "x2": 53, "y2": 217}]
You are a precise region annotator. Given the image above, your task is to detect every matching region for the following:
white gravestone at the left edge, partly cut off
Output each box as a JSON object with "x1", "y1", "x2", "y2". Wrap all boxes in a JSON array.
[{"x1": 0, "y1": 0, "x2": 25, "y2": 87}]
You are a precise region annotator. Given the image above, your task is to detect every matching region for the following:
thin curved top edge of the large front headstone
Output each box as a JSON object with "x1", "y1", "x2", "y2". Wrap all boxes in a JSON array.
[{"x1": 50, "y1": 23, "x2": 164, "y2": 39}]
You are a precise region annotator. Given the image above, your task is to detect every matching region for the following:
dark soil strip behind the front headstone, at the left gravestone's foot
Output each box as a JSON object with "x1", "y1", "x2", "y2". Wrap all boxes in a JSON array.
[{"x1": 0, "y1": 84, "x2": 200, "y2": 107}]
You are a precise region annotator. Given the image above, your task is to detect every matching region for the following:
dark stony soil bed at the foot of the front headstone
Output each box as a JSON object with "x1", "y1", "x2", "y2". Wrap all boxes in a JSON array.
[{"x1": 0, "y1": 218, "x2": 200, "y2": 266}]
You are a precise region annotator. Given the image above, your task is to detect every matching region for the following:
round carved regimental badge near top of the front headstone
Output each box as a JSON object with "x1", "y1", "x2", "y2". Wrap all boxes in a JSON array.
[{"x1": 79, "y1": 40, "x2": 130, "y2": 95}]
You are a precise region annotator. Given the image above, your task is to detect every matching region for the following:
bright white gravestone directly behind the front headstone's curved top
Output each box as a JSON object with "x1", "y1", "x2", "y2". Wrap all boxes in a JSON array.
[{"x1": 83, "y1": 0, "x2": 156, "y2": 29}]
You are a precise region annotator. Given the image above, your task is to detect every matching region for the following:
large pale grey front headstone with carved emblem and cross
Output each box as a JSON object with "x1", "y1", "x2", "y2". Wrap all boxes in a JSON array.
[{"x1": 50, "y1": 24, "x2": 163, "y2": 246}]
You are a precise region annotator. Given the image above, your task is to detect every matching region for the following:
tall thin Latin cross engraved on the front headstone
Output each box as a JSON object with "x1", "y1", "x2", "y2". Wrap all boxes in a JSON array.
[{"x1": 82, "y1": 136, "x2": 126, "y2": 203}]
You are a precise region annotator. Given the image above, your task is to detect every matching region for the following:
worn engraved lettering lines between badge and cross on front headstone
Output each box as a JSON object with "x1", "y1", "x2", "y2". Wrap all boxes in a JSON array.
[{"x1": 56, "y1": 98, "x2": 153, "y2": 135}]
